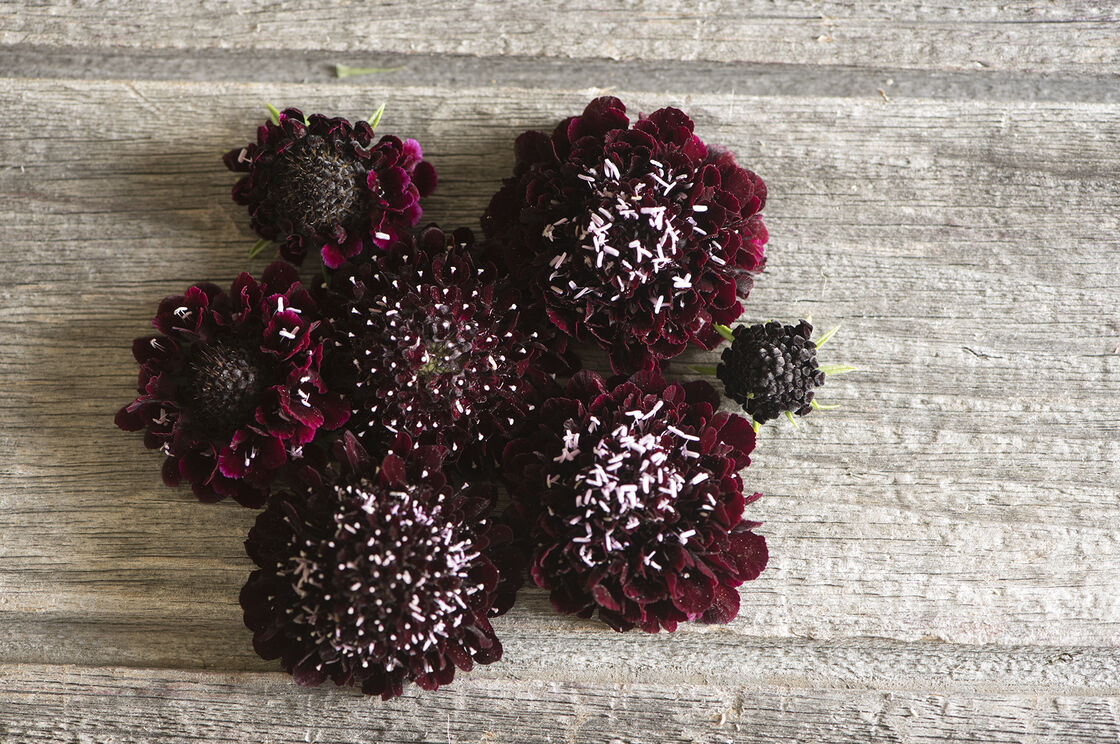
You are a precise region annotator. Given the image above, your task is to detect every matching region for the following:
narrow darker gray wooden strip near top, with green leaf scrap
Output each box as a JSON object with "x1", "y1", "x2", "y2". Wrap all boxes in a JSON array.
[{"x1": 0, "y1": 45, "x2": 1120, "y2": 103}]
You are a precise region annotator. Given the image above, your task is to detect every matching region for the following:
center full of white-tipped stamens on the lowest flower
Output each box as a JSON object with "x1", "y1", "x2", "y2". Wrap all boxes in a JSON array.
[{"x1": 282, "y1": 486, "x2": 482, "y2": 671}]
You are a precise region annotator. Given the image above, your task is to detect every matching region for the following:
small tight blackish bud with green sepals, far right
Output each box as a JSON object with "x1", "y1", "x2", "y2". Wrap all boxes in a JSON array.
[{"x1": 716, "y1": 320, "x2": 824, "y2": 424}]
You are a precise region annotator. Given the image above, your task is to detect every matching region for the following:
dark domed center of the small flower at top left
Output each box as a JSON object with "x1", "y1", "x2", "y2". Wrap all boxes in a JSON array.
[{"x1": 269, "y1": 136, "x2": 361, "y2": 232}]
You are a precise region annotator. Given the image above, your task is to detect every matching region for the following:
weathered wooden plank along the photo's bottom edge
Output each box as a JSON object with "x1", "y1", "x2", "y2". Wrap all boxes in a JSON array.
[{"x1": 0, "y1": 664, "x2": 1120, "y2": 744}]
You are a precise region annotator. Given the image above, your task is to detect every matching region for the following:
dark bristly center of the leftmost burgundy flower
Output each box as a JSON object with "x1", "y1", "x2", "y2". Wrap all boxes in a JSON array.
[{"x1": 186, "y1": 342, "x2": 267, "y2": 434}]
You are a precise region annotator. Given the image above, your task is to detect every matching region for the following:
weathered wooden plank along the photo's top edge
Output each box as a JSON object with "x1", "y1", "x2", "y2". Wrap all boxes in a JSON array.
[{"x1": 0, "y1": 0, "x2": 1120, "y2": 74}]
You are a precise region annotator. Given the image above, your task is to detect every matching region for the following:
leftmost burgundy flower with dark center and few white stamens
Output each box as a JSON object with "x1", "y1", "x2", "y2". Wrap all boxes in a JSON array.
[{"x1": 116, "y1": 261, "x2": 347, "y2": 506}]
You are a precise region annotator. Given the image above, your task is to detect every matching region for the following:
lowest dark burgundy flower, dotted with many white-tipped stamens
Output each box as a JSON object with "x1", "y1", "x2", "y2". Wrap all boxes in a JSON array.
[{"x1": 241, "y1": 447, "x2": 511, "y2": 700}]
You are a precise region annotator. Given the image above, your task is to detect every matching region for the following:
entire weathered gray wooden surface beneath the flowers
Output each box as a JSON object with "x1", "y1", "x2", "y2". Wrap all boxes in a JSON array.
[{"x1": 0, "y1": 0, "x2": 1120, "y2": 744}]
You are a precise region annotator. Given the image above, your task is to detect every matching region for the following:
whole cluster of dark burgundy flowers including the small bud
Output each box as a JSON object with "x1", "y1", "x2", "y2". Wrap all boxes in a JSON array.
[{"x1": 116, "y1": 97, "x2": 850, "y2": 699}]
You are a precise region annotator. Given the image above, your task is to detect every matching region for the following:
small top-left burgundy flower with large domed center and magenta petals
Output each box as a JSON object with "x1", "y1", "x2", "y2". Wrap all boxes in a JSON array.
[{"x1": 225, "y1": 109, "x2": 436, "y2": 269}]
